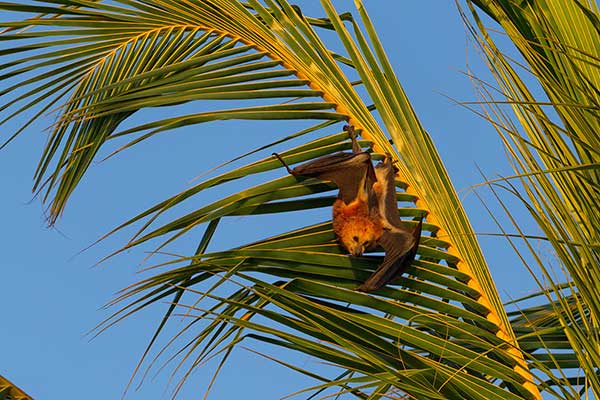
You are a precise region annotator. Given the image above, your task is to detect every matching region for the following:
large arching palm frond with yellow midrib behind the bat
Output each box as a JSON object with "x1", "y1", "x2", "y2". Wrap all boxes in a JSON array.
[{"x1": 0, "y1": 0, "x2": 543, "y2": 399}]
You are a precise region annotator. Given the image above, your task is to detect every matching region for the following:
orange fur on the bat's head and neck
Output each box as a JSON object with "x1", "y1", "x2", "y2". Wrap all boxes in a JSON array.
[{"x1": 333, "y1": 197, "x2": 383, "y2": 256}]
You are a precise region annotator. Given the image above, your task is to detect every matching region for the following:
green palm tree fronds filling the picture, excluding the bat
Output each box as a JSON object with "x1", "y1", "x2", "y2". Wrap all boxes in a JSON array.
[{"x1": 0, "y1": 0, "x2": 600, "y2": 399}]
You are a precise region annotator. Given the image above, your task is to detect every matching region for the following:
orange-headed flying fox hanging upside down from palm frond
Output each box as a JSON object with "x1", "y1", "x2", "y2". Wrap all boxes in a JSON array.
[{"x1": 274, "y1": 125, "x2": 422, "y2": 292}]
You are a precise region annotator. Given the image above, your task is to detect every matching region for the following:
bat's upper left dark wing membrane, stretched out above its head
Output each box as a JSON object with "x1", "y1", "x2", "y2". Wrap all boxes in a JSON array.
[{"x1": 291, "y1": 152, "x2": 376, "y2": 204}]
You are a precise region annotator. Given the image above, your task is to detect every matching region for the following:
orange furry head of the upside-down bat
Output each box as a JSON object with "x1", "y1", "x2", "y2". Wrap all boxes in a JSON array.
[{"x1": 337, "y1": 217, "x2": 382, "y2": 256}]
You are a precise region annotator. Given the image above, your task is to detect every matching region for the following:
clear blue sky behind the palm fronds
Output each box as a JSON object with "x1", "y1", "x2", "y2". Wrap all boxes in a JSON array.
[{"x1": 0, "y1": 0, "x2": 533, "y2": 400}]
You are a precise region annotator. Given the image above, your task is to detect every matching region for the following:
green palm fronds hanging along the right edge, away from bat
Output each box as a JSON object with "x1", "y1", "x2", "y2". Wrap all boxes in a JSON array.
[{"x1": 470, "y1": 0, "x2": 600, "y2": 398}]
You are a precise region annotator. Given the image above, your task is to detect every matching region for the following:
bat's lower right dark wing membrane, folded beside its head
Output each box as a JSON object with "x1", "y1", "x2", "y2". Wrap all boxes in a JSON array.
[{"x1": 356, "y1": 219, "x2": 423, "y2": 292}]
